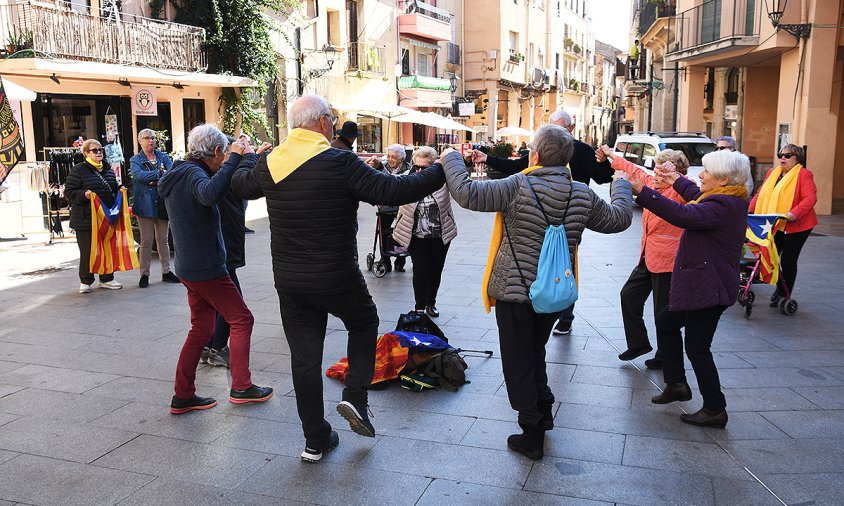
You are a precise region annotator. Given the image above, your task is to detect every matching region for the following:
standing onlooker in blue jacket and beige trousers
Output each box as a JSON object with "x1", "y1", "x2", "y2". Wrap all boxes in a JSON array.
[{"x1": 129, "y1": 128, "x2": 179, "y2": 288}]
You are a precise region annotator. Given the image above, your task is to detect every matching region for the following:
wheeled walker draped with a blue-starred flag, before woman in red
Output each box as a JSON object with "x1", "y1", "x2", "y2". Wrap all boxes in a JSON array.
[{"x1": 738, "y1": 214, "x2": 797, "y2": 318}]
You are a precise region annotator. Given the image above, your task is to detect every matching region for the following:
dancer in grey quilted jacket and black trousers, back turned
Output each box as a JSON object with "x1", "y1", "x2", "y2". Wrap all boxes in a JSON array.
[{"x1": 442, "y1": 125, "x2": 633, "y2": 460}]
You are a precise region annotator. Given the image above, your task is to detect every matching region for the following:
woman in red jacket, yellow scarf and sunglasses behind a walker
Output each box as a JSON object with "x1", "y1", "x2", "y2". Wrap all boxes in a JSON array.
[{"x1": 750, "y1": 144, "x2": 818, "y2": 307}]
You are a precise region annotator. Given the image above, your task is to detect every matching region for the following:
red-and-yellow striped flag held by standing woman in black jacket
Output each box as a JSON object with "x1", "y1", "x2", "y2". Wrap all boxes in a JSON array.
[{"x1": 90, "y1": 188, "x2": 138, "y2": 274}]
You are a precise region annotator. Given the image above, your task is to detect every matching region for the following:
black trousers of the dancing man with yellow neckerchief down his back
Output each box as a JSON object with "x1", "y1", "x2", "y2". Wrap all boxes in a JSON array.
[{"x1": 278, "y1": 285, "x2": 378, "y2": 448}]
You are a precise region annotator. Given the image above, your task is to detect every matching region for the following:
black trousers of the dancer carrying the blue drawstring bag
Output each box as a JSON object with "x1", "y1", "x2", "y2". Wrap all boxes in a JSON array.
[{"x1": 495, "y1": 300, "x2": 560, "y2": 428}]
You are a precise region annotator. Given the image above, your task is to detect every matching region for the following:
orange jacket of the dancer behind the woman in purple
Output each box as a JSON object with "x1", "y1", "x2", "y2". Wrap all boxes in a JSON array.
[{"x1": 612, "y1": 157, "x2": 686, "y2": 273}]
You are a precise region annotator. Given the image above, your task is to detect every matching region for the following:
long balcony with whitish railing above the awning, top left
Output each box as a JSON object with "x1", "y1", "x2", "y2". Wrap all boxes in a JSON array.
[{"x1": 0, "y1": 0, "x2": 207, "y2": 72}]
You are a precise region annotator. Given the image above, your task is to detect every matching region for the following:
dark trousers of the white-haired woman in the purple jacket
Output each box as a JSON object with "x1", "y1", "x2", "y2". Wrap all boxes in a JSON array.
[{"x1": 656, "y1": 306, "x2": 727, "y2": 411}]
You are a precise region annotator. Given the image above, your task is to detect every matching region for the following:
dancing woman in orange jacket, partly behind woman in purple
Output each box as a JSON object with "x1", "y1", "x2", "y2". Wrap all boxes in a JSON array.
[{"x1": 596, "y1": 146, "x2": 689, "y2": 369}]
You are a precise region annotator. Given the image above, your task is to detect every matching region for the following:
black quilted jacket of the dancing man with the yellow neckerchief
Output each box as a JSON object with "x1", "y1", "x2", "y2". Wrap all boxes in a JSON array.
[{"x1": 227, "y1": 148, "x2": 445, "y2": 294}]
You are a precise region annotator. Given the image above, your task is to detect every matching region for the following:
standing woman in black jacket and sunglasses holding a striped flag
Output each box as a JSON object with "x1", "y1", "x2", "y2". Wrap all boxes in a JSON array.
[{"x1": 64, "y1": 139, "x2": 123, "y2": 293}]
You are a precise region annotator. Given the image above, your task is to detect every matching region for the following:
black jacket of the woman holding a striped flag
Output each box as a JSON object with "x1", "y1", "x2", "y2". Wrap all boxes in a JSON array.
[{"x1": 64, "y1": 162, "x2": 119, "y2": 230}]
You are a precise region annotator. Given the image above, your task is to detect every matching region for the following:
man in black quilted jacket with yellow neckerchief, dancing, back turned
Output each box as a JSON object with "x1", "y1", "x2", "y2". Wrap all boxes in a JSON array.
[{"x1": 227, "y1": 95, "x2": 445, "y2": 462}]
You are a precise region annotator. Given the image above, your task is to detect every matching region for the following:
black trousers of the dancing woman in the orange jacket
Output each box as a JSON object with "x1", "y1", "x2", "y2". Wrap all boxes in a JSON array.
[{"x1": 621, "y1": 258, "x2": 671, "y2": 356}]
